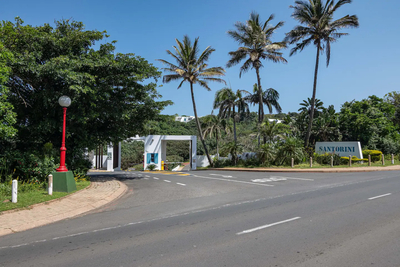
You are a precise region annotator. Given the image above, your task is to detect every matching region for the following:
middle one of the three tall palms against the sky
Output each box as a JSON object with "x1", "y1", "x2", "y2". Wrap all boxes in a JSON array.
[{"x1": 226, "y1": 12, "x2": 287, "y2": 130}]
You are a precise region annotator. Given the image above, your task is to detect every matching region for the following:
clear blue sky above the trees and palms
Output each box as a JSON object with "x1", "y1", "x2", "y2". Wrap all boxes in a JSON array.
[{"x1": 0, "y1": 0, "x2": 400, "y2": 116}]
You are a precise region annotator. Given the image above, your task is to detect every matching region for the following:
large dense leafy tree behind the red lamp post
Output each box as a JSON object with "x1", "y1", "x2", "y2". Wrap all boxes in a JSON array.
[{"x1": 0, "y1": 18, "x2": 171, "y2": 157}]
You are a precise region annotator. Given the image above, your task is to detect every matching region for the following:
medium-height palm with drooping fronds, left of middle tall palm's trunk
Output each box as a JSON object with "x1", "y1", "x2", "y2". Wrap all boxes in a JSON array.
[{"x1": 214, "y1": 87, "x2": 249, "y2": 143}]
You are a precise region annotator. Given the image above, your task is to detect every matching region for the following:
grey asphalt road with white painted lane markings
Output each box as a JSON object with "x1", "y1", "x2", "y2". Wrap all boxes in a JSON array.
[{"x1": 0, "y1": 171, "x2": 400, "y2": 267}]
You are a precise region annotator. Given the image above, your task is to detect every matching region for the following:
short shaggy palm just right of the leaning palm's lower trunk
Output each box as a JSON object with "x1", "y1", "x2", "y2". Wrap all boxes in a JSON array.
[{"x1": 203, "y1": 115, "x2": 232, "y2": 159}]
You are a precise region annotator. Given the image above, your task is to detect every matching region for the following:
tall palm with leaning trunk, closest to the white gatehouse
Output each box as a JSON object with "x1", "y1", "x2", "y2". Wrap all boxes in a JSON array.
[{"x1": 158, "y1": 35, "x2": 225, "y2": 166}]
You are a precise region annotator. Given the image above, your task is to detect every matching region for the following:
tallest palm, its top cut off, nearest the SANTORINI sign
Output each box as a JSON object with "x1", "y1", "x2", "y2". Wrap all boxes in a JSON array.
[{"x1": 285, "y1": 0, "x2": 359, "y2": 147}]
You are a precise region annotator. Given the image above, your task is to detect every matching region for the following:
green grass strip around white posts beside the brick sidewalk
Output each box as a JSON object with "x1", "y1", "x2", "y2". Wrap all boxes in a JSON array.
[{"x1": 0, "y1": 181, "x2": 90, "y2": 212}]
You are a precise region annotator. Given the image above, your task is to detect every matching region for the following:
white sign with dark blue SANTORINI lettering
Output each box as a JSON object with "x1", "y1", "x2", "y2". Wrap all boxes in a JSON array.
[{"x1": 315, "y1": 142, "x2": 363, "y2": 159}]
